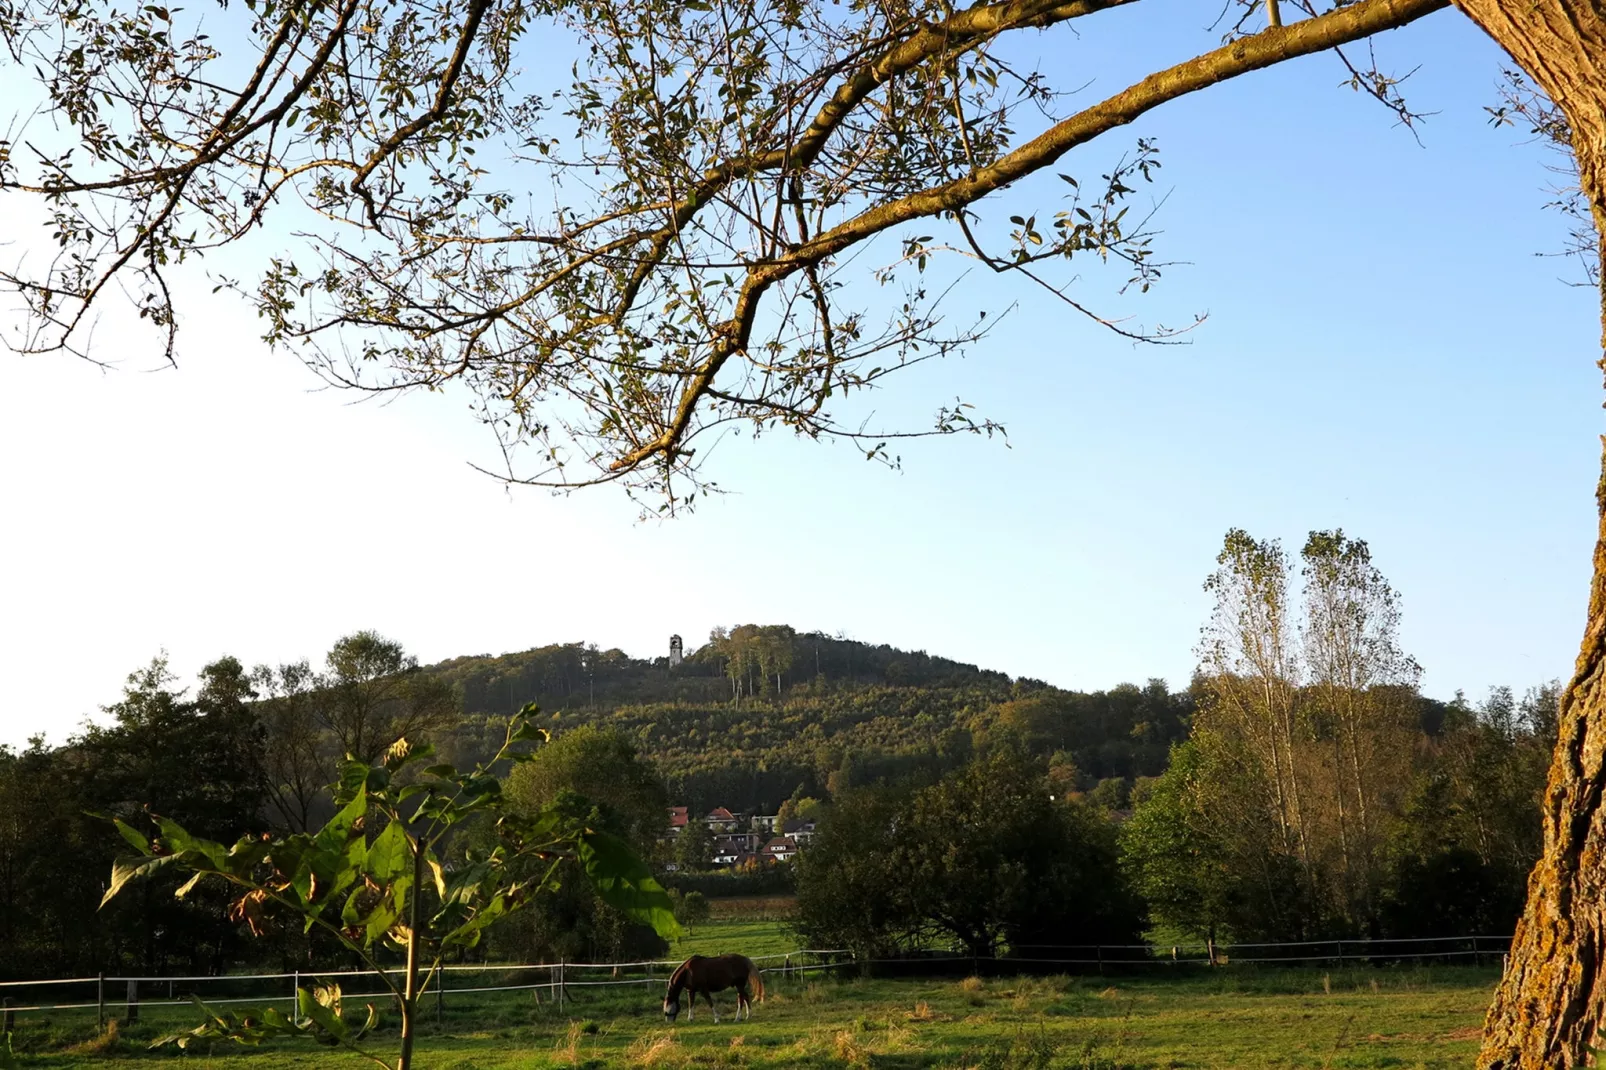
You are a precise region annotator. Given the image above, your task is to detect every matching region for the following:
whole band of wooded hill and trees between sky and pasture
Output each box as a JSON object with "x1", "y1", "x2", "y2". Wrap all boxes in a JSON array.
[{"x1": 0, "y1": 530, "x2": 1559, "y2": 1002}]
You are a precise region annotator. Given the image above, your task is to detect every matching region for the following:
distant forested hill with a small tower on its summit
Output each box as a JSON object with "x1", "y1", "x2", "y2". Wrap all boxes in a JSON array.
[{"x1": 427, "y1": 625, "x2": 1192, "y2": 813}]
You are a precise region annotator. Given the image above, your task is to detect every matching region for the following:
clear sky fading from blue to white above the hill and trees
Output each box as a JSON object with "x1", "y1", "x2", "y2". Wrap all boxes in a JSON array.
[{"x1": 0, "y1": 0, "x2": 1601, "y2": 745}]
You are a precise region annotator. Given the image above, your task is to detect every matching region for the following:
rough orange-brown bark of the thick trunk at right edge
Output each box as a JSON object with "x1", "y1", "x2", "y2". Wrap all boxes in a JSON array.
[{"x1": 1457, "y1": 0, "x2": 1606, "y2": 1070}]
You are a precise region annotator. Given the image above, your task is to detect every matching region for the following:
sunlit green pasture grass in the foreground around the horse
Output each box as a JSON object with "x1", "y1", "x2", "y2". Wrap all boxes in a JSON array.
[{"x1": 6, "y1": 967, "x2": 1497, "y2": 1070}]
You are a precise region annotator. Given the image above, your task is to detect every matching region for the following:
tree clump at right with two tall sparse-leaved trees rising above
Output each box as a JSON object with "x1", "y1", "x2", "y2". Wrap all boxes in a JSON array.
[{"x1": 1126, "y1": 530, "x2": 1559, "y2": 940}]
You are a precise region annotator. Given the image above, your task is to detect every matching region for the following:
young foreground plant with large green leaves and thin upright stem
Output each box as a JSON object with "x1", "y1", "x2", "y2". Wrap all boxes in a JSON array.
[{"x1": 103, "y1": 705, "x2": 679, "y2": 1070}]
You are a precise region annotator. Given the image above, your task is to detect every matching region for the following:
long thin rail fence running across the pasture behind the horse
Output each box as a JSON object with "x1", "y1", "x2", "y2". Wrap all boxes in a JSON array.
[{"x1": 0, "y1": 935, "x2": 1511, "y2": 1028}]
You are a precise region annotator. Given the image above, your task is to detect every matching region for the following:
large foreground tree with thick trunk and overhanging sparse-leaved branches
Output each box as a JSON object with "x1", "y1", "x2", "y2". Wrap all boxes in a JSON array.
[{"x1": 0, "y1": 0, "x2": 1606, "y2": 1068}]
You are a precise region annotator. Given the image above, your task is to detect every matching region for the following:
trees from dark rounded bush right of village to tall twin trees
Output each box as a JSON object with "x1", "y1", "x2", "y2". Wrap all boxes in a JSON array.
[{"x1": 798, "y1": 530, "x2": 1559, "y2": 954}]
